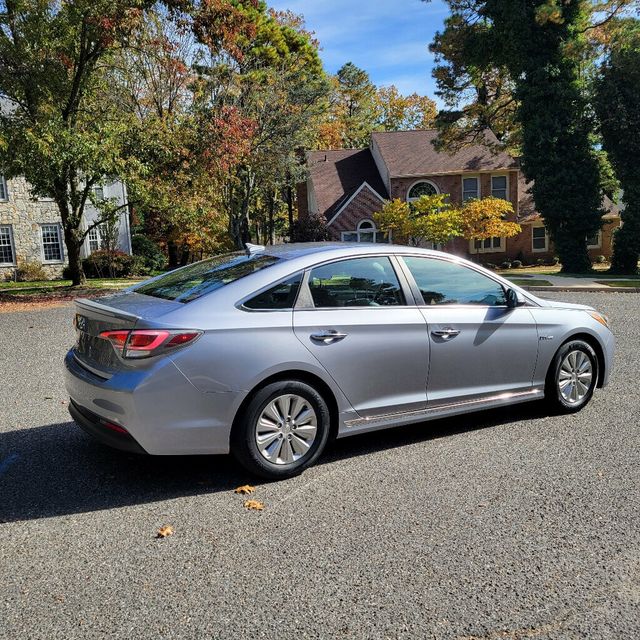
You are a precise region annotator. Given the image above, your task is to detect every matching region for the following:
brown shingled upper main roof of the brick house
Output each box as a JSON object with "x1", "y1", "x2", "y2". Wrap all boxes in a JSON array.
[{"x1": 371, "y1": 129, "x2": 518, "y2": 178}]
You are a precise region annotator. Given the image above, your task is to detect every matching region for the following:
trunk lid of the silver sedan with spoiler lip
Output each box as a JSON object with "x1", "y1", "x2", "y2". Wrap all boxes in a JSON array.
[{"x1": 73, "y1": 292, "x2": 183, "y2": 379}]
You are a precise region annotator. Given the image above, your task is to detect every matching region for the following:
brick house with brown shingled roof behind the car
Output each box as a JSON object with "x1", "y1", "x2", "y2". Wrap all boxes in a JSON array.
[{"x1": 298, "y1": 130, "x2": 620, "y2": 264}]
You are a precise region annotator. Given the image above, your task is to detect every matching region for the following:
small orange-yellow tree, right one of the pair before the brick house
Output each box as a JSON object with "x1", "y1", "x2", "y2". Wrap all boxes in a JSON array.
[{"x1": 460, "y1": 196, "x2": 522, "y2": 240}]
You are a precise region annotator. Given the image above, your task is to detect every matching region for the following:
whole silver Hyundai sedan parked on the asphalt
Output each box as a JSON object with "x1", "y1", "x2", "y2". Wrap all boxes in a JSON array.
[{"x1": 65, "y1": 243, "x2": 615, "y2": 478}]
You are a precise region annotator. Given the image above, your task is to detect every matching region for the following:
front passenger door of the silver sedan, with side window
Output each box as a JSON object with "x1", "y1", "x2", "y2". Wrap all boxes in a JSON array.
[{"x1": 404, "y1": 257, "x2": 538, "y2": 406}]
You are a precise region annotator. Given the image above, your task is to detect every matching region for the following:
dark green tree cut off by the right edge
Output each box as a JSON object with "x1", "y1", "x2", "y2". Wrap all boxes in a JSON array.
[{"x1": 595, "y1": 19, "x2": 640, "y2": 274}]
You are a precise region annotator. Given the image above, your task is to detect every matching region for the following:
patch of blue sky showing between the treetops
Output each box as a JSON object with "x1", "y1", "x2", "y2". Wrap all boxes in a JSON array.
[{"x1": 267, "y1": 0, "x2": 448, "y2": 98}]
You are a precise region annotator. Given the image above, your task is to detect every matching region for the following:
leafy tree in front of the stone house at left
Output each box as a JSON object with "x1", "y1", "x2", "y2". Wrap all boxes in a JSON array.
[{"x1": 0, "y1": 0, "x2": 142, "y2": 285}]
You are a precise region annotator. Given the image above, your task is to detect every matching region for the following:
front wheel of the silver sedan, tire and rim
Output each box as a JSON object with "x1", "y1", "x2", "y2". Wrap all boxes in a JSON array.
[{"x1": 545, "y1": 340, "x2": 598, "y2": 413}]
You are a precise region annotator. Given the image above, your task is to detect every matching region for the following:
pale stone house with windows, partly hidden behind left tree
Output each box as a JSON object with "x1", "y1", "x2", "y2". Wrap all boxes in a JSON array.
[{"x1": 0, "y1": 175, "x2": 131, "y2": 280}]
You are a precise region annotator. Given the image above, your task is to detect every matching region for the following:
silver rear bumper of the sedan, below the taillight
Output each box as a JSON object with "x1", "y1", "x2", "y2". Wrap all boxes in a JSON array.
[{"x1": 65, "y1": 349, "x2": 242, "y2": 455}]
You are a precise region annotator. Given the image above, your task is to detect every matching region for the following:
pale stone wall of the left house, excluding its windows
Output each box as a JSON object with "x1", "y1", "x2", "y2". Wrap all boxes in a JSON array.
[{"x1": 0, "y1": 177, "x2": 131, "y2": 279}]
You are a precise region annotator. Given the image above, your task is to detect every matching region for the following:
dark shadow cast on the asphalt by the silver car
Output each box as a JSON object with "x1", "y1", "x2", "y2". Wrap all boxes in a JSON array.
[{"x1": 0, "y1": 403, "x2": 544, "y2": 523}]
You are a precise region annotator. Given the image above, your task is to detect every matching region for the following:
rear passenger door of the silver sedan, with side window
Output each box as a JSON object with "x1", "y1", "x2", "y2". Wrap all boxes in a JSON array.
[{"x1": 293, "y1": 256, "x2": 429, "y2": 417}]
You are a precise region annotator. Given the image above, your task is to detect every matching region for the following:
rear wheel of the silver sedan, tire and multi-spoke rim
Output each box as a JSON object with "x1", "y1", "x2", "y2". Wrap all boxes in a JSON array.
[{"x1": 231, "y1": 380, "x2": 331, "y2": 480}]
